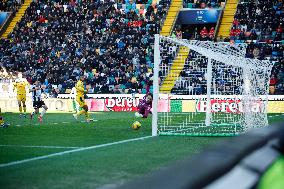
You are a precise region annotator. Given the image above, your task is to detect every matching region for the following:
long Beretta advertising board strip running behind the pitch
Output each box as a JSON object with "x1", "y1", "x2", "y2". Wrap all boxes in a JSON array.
[{"x1": 0, "y1": 94, "x2": 284, "y2": 113}]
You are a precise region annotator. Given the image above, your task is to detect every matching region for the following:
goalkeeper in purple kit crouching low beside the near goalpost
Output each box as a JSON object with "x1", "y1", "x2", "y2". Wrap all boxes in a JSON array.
[{"x1": 135, "y1": 85, "x2": 153, "y2": 118}]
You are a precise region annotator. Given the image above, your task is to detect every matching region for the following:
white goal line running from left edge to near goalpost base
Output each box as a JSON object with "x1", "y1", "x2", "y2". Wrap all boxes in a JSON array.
[{"x1": 0, "y1": 136, "x2": 152, "y2": 168}]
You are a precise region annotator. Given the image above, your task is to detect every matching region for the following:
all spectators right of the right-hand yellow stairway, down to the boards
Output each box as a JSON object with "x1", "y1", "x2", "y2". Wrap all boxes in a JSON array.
[{"x1": 230, "y1": 0, "x2": 284, "y2": 94}]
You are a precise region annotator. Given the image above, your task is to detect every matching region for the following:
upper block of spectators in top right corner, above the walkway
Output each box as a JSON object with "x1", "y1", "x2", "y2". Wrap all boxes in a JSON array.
[{"x1": 230, "y1": 0, "x2": 284, "y2": 41}]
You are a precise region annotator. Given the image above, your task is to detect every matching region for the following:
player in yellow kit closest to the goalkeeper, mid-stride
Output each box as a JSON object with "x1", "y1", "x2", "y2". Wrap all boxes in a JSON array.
[{"x1": 73, "y1": 76, "x2": 92, "y2": 122}]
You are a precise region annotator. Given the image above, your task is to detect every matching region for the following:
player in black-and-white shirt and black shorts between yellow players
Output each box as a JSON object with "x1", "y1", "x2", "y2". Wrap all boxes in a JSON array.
[{"x1": 30, "y1": 80, "x2": 48, "y2": 123}]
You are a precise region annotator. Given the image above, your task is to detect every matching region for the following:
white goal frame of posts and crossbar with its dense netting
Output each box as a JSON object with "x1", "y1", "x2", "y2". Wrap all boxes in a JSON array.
[{"x1": 152, "y1": 34, "x2": 273, "y2": 136}]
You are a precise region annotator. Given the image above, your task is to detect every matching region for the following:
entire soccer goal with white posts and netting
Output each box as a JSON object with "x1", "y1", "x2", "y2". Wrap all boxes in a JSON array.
[{"x1": 152, "y1": 34, "x2": 273, "y2": 136}]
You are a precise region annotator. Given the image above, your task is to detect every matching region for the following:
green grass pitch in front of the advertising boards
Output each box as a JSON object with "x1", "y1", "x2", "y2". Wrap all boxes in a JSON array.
[{"x1": 0, "y1": 112, "x2": 283, "y2": 189}]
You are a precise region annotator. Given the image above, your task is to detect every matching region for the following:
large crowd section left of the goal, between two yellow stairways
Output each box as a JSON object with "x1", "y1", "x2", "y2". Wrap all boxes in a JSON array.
[{"x1": 0, "y1": 0, "x2": 170, "y2": 93}]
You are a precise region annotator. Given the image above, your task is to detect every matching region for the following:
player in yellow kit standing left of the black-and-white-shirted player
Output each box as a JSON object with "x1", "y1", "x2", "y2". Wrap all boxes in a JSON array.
[{"x1": 14, "y1": 72, "x2": 29, "y2": 116}]
